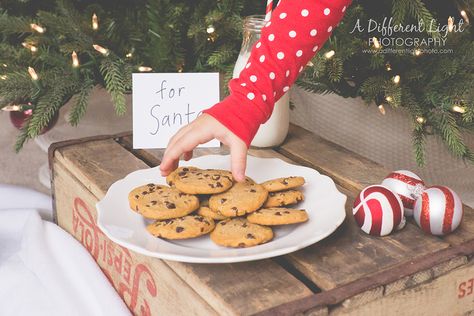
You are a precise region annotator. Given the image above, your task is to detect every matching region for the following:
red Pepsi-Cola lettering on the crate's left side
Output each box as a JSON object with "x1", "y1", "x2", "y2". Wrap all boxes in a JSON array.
[{"x1": 72, "y1": 198, "x2": 157, "y2": 315}]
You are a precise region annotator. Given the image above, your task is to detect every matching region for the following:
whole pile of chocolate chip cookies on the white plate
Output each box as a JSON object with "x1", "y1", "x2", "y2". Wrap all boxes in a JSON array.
[{"x1": 129, "y1": 167, "x2": 308, "y2": 247}]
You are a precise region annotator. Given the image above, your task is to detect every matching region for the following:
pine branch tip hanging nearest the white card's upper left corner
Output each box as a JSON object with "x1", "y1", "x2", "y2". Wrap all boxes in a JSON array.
[{"x1": 100, "y1": 57, "x2": 127, "y2": 115}]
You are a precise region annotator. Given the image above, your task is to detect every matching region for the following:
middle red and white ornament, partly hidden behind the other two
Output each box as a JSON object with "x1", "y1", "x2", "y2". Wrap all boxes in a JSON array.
[{"x1": 382, "y1": 170, "x2": 425, "y2": 216}]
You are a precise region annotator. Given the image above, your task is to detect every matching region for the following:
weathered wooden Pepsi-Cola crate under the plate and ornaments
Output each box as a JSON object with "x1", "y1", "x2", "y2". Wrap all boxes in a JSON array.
[{"x1": 49, "y1": 126, "x2": 474, "y2": 315}]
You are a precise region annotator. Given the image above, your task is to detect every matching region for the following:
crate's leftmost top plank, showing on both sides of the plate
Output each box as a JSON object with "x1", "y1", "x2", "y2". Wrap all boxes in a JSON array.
[{"x1": 51, "y1": 140, "x2": 312, "y2": 315}]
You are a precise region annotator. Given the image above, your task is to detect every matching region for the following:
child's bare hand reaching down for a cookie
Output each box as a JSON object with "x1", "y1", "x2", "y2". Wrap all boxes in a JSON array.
[{"x1": 160, "y1": 113, "x2": 247, "y2": 182}]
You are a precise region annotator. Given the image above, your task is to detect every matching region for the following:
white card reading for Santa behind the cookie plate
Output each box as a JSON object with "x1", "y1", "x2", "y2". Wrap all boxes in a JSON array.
[{"x1": 132, "y1": 73, "x2": 220, "y2": 148}]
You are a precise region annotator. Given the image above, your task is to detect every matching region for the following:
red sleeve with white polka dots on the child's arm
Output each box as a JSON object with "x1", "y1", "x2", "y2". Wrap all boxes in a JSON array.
[{"x1": 204, "y1": 0, "x2": 351, "y2": 146}]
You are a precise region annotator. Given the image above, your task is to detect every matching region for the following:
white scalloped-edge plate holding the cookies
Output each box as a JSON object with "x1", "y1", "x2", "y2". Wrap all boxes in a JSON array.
[{"x1": 97, "y1": 155, "x2": 346, "y2": 263}]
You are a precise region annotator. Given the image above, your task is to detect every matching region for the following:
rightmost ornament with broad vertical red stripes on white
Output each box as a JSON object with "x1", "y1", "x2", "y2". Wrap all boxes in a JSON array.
[{"x1": 413, "y1": 186, "x2": 463, "y2": 236}]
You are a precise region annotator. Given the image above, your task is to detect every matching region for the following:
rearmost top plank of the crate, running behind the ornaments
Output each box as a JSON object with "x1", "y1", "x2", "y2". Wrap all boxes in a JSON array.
[{"x1": 277, "y1": 125, "x2": 474, "y2": 245}]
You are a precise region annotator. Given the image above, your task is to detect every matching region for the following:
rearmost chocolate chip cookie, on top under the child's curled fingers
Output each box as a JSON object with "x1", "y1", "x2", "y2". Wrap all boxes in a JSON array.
[{"x1": 172, "y1": 168, "x2": 233, "y2": 194}]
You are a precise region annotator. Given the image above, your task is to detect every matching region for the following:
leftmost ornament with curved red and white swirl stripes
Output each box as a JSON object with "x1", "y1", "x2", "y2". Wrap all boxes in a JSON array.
[{"x1": 352, "y1": 185, "x2": 405, "y2": 236}]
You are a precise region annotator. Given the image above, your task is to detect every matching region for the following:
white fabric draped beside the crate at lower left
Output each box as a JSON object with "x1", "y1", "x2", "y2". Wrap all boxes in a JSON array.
[{"x1": 0, "y1": 184, "x2": 130, "y2": 316}]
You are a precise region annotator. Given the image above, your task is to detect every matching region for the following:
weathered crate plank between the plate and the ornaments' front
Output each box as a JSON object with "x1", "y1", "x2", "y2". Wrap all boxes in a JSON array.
[{"x1": 287, "y1": 188, "x2": 449, "y2": 290}]
